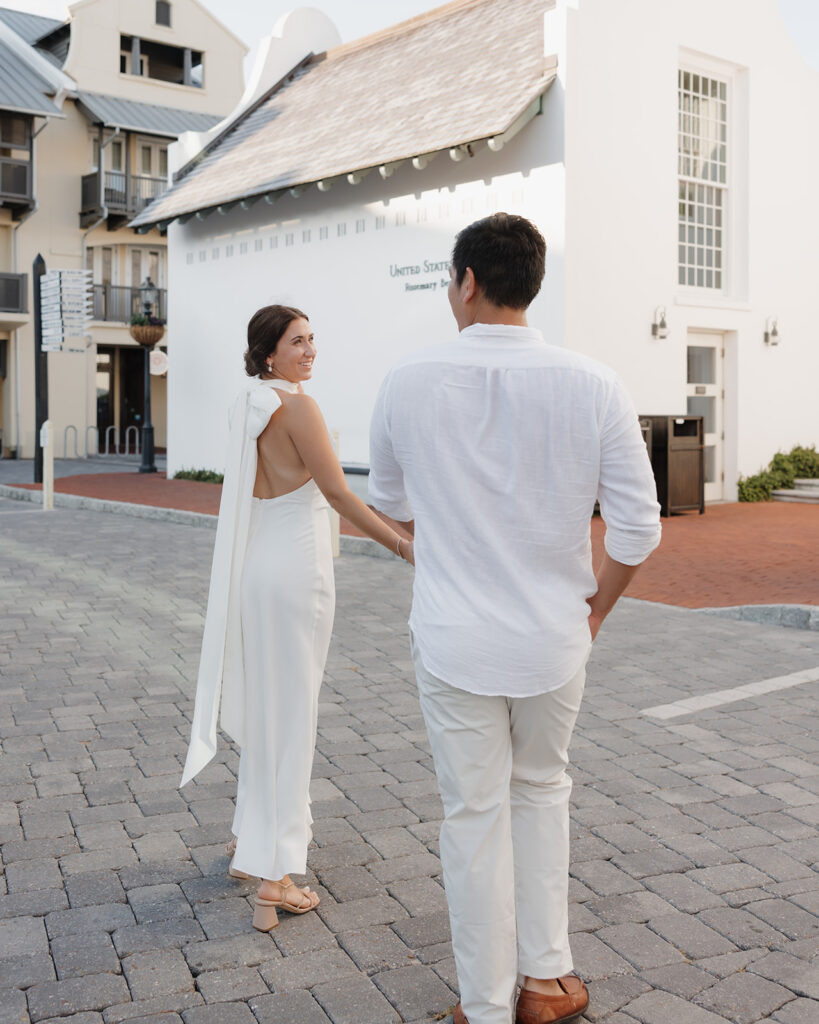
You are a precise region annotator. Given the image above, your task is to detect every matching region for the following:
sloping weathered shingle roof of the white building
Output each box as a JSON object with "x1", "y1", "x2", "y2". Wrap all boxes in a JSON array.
[{"x1": 132, "y1": 0, "x2": 554, "y2": 226}]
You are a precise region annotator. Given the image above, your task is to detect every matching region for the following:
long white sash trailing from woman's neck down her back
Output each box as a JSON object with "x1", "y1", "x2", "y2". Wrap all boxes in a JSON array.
[{"x1": 179, "y1": 377, "x2": 298, "y2": 786}]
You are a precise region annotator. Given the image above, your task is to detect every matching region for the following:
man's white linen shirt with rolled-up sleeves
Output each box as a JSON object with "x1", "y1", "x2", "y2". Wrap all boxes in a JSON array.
[{"x1": 370, "y1": 324, "x2": 660, "y2": 697}]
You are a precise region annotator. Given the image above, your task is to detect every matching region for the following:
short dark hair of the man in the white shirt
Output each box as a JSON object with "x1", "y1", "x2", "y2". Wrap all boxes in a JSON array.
[{"x1": 452, "y1": 213, "x2": 546, "y2": 309}]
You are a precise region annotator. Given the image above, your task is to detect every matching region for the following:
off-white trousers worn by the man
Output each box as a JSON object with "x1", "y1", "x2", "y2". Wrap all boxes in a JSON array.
[{"x1": 413, "y1": 644, "x2": 586, "y2": 1024}]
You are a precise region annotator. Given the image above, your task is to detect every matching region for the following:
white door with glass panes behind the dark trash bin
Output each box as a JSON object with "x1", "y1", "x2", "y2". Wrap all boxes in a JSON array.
[{"x1": 686, "y1": 331, "x2": 725, "y2": 502}]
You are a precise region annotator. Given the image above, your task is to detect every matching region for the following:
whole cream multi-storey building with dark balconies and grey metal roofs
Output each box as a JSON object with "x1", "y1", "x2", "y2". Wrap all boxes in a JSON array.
[{"x1": 0, "y1": 0, "x2": 246, "y2": 458}]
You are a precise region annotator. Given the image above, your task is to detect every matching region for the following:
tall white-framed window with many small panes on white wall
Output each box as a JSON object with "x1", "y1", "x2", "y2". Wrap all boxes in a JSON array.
[{"x1": 677, "y1": 70, "x2": 728, "y2": 290}]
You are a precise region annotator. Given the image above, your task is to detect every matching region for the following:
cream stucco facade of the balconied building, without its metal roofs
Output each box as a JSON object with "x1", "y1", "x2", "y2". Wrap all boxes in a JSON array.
[{"x1": 0, "y1": 0, "x2": 246, "y2": 458}]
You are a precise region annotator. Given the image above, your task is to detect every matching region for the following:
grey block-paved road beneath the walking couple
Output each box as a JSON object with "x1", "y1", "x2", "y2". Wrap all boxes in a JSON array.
[{"x1": 0, "y1": 501, "x2": 819, "y2": 1024}]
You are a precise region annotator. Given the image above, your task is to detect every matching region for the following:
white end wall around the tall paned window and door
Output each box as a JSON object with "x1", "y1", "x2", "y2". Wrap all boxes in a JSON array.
[{"x1": 565, "y1": 0, "x2": 819, "y2": 498}]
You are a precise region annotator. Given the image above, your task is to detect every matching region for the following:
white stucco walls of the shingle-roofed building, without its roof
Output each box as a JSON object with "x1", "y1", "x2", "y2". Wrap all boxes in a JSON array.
[{"x1": 151, "y1": 0, "x2": 819, "y2": 500}]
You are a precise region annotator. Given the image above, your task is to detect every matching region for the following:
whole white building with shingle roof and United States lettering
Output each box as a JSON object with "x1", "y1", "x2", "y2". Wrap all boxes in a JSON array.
[{"x1": 133, "y1": 0, "x2": 819, "y2": 501}]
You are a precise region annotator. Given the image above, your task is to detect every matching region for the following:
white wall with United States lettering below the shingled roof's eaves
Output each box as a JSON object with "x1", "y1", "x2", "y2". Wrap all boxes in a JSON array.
[{"x1": 163, "y1": 100, "x2": 563, "y2": 473}]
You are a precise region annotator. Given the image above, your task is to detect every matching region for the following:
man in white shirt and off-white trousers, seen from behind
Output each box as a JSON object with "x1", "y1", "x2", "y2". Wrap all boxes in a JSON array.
[{"x1": 370, "y1": 213, "x2": 660, "y2": 1024}]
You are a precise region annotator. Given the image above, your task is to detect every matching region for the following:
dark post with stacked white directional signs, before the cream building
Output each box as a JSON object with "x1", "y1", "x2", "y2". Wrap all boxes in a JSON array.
[{"x1": 33, "y1": 255, "x2": 93, "y2": 483}]
